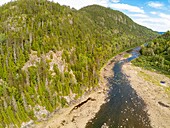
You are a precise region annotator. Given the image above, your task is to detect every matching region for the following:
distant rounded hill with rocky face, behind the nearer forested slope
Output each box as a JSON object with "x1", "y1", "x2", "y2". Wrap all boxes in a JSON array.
[{"x1": 80, "y1": 5, "x2": 155, "y2": 41}]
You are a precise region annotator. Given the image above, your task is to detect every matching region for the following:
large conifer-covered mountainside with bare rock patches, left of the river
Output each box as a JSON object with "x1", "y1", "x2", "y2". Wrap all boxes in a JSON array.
[{"x1": 0, "y1": 0, "x2": 158, "y2": 127}]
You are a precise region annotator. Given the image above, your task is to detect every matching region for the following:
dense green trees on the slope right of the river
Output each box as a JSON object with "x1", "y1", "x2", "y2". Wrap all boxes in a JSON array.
[{"x1": 133, "y1": 31, "x2": 170, "y2": 76}]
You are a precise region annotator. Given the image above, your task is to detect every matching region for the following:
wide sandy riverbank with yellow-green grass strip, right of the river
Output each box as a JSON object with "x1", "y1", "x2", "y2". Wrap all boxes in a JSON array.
[{"x1": 122, "y1": 63, "x2": 170, "y2": 128}]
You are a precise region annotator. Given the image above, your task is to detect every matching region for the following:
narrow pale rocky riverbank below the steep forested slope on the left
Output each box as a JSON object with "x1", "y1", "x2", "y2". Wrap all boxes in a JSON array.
[{"x1": 36, "y1": 52, "x2": 128, "y2": 128}]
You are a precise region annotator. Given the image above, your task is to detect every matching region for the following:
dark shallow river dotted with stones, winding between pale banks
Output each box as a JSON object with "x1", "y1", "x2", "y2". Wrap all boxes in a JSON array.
[{"x1": 86, "y1": 47, "x2": 151, "y2": 128}]
